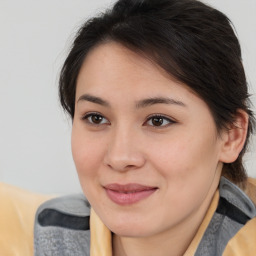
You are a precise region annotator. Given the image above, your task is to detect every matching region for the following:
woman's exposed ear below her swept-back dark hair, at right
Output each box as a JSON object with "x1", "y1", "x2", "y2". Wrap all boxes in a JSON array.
[{"x1": 220, "y1": 109, "x2": 249, "y2": 163}]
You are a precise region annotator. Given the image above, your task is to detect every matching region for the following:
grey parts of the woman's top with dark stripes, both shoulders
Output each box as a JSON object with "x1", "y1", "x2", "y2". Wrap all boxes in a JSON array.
[{"x1": 34, "y1": 177, "x2": 256, "y2": 256}]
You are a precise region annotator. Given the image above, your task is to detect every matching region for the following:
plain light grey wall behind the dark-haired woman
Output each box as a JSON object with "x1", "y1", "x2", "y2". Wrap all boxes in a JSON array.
[{"x1": 0, "y1": 0, "x2": 256, "y2": 194}]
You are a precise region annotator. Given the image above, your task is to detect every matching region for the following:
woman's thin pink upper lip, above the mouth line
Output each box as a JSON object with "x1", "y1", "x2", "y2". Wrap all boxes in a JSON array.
[{"x1": 104, "y1": 183, "x2": 157, "y2": 193}]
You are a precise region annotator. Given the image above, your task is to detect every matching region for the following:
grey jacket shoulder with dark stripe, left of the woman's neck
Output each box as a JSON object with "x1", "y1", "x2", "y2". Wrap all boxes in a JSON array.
[{"x1": 34, "y1": 194, "x2": 90, "y2": 256}]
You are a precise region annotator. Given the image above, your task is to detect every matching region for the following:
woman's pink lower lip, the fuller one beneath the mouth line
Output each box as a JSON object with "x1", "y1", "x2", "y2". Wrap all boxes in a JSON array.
[{"x1": 106, "y1": 188, "x2": 157, "y2": 205}]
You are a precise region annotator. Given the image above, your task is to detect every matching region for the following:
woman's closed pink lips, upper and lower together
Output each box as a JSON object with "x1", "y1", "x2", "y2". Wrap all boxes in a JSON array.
[{"x1": 104, "y1": 183, "x2": 157, "y2": 205}]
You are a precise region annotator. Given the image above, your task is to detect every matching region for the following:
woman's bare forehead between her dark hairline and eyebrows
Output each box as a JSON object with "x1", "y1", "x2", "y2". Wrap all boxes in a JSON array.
[{"x1": 77, "y1": 42, "x2": 193, "y2": 98}]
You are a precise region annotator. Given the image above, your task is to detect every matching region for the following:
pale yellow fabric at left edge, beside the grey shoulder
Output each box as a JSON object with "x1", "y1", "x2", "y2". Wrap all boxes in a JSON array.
[{"x1": 0, "y1": 183, "x2": 50, "y2": 256}]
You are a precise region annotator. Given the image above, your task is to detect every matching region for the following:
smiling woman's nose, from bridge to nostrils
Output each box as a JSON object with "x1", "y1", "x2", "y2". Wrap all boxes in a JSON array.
[{"x1": 104, "y1": 128, "x2": 145, "y2": 172}]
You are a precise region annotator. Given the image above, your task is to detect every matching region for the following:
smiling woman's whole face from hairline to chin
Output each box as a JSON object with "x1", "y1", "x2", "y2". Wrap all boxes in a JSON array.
[{"x1": 72, "y1": 42, "x2": 223, "y2": 237}]
